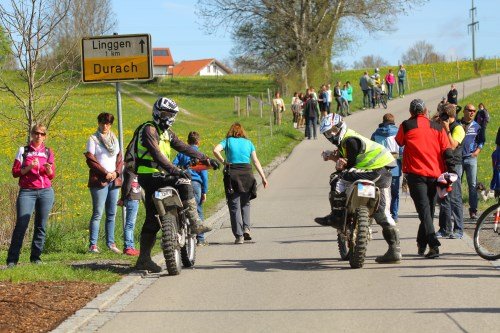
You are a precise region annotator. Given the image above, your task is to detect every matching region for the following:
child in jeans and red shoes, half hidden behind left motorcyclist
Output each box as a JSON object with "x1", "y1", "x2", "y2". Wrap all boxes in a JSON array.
[{"x1": 118, "y1": 168, "x2": 142, "y2": 256}]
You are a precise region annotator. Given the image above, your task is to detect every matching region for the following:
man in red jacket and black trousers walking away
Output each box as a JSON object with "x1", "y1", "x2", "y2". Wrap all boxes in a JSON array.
[{"x1": 396, "y1": 99, "x2": 453, "y2": 259}]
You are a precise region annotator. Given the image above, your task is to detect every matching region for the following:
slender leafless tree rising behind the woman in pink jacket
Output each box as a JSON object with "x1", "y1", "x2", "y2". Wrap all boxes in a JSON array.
[{"x1": 0, "y1": 0, "x2": 79, "y2": 137}]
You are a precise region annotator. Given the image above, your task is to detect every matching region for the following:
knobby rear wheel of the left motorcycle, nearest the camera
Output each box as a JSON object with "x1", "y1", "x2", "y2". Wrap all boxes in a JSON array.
[{"x1": 161, "y1": 212, "x2": 182, "y2": 275}]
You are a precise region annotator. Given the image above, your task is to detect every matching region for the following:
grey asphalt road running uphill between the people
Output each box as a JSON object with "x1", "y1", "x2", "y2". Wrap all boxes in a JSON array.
[{"x1": 95, "y1": 76, "x2": 500, "y2": 332}]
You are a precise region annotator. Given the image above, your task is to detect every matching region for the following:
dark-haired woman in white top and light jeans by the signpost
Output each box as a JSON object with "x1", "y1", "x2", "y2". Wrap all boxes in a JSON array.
[{"x1": 85, "y1": 112, "x2": 123, "y2": 253}]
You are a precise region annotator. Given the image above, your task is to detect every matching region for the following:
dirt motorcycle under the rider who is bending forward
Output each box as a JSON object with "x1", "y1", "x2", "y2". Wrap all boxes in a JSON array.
[{"x1": 337, "y1": 180, "x2": 380, "y2": 268}]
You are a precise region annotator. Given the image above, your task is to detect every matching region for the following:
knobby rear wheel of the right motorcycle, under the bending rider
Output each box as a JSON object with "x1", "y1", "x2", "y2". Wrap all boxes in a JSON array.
[{"x1": 349, "y1": 206, "x2": 370, "y2": 268}]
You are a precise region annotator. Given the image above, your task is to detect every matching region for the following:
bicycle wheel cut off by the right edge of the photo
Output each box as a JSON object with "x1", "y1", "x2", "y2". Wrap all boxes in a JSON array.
[{"x1": 474, "y1": 203, "x2": 500, "y2": 260}]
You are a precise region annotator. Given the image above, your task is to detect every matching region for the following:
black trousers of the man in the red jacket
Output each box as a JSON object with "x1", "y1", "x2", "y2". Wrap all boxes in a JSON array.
[{"x1": 407, "y1": 173, "x2": 441, "y2": 247}]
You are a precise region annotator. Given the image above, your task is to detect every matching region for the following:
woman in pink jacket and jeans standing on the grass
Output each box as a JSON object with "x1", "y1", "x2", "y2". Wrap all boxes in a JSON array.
[{"x1": 7, "y1": 124, "x2": 55, "y2": 268}]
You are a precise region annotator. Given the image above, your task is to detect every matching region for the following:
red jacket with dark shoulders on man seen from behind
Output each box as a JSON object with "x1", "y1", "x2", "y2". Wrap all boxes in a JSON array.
[{"x1": 396, "y1": 114, "x2": 450, "y2": 178}]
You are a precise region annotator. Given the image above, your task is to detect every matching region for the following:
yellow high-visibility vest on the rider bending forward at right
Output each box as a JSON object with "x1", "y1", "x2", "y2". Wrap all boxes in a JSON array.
[{"x1": 341, "y1": 129, "x2": 394, "y2": 170}]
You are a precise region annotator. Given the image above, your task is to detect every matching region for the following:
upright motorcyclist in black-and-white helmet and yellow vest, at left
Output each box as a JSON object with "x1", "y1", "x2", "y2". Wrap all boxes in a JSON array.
[{"x1": 136, "y1": 97, "x2": 219, "y2": 273}]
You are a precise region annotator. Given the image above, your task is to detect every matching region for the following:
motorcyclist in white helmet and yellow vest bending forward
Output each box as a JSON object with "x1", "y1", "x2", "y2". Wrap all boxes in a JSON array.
[{"x1": 315, "y1": 114, "x2": 401, "y2": 263}]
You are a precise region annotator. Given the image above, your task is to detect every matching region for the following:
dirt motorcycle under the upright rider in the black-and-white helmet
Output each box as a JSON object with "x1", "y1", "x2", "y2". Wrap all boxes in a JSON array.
[{"x1": 153, "y1": 161, "x2": 210, "y2": 275}]
